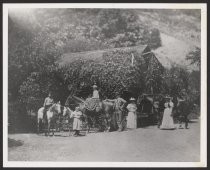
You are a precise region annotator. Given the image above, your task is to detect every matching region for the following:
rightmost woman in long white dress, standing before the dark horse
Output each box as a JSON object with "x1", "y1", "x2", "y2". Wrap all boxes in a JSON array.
[{"x1": 160, "y1": 97, "x2": 175, "y2": 129}]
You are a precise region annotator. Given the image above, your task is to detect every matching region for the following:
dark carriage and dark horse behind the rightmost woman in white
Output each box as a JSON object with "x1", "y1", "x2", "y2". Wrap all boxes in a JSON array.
[{"x1": 137, "y1": 94, "x2": 199, "y2": 127}]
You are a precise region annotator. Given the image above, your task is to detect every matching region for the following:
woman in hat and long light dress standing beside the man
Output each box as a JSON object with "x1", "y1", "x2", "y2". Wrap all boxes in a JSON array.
[{"x1": 127, "y1": 97, "x2": 137, "y2": 129}]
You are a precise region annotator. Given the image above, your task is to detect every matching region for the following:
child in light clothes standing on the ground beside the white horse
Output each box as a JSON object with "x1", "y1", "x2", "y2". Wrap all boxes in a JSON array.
[{"x1": 70, "y1": 107, "x2": 82, "y2": 136}]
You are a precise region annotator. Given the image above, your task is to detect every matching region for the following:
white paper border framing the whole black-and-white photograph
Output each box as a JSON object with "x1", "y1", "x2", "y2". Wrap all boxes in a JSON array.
[{"x1": 3, "y1": 3, "x2": 207, "y2": 167}]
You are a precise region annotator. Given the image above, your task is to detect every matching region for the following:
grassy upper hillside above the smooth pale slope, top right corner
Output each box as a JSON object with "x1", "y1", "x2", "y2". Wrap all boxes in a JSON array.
[{"x1": 137, "y1": 9, "x2": 201, "y2": 47}]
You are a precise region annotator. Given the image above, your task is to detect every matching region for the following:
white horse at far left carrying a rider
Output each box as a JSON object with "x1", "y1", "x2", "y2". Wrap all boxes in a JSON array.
[{"x1": 37, "y1": 102, "x2": 61, "y2": 136}]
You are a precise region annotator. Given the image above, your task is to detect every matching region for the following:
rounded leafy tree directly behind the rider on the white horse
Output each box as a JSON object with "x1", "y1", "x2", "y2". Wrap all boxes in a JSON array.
[{"x1": 19, "y1": 67, "x2": 68, "y2": 111}]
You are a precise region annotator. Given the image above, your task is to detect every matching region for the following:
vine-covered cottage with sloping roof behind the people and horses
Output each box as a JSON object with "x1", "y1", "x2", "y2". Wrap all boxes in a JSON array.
[{"x1": 60, "y1": 45, "x2": 164, "y2": 97}]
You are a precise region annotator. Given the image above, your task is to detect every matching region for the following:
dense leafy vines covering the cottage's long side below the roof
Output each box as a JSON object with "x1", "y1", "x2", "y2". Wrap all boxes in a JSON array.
[{"x1": 62, "y1": 50, "x2": 146, "y2": 98}]
